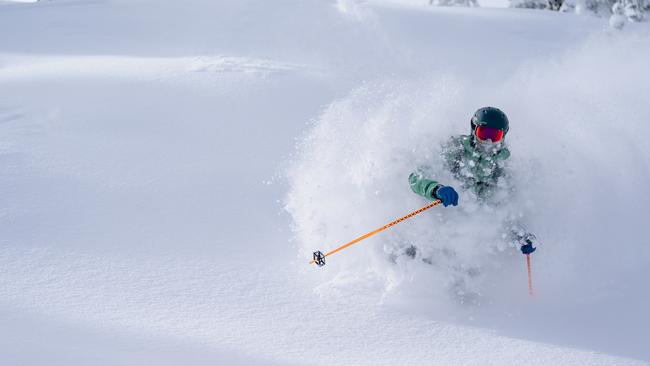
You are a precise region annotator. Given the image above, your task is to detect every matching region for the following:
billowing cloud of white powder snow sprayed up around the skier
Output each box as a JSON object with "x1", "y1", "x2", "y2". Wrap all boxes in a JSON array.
[{"x1": 287, "y1": 28, "x2": 650, "y2": 349}]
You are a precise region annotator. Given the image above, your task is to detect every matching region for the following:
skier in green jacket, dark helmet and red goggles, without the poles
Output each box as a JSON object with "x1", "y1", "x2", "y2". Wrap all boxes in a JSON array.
[{"x1": 409, "y1": 107, "x2": 537, "y2": 255}]
